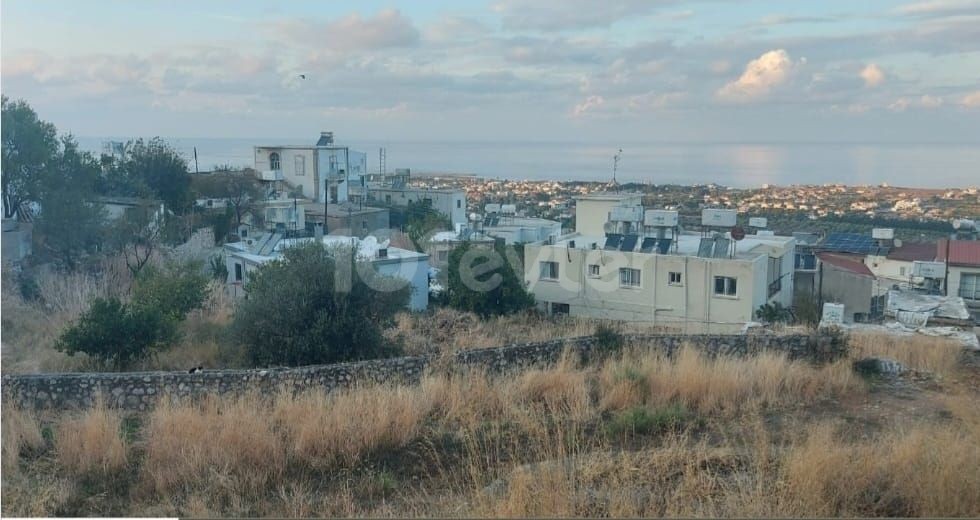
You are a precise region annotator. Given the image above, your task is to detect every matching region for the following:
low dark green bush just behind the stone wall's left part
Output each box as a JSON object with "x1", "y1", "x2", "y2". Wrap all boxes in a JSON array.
[{"x1": 55, "y1": 297, "x2": 177, "y2": 370}]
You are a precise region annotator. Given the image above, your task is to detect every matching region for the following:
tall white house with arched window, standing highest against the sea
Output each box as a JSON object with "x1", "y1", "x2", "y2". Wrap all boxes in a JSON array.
[{"x1": 254, "y1": 132, "x2": 367, "y2": 202}]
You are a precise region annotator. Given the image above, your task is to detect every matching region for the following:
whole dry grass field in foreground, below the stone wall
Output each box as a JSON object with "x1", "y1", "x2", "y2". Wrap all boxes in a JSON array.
[{"x1": 2, "y1": 336, "x2": 980, "y2": 517}]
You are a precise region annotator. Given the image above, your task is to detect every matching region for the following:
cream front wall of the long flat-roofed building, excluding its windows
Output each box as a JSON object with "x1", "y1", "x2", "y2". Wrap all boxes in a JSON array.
[{"x1": 524, "y1": 244, "x2": 776, "y2": 333}]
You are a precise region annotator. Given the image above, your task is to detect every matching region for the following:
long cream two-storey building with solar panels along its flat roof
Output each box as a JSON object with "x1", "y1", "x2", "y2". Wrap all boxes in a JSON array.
[{"x1": 524, "y1": 231, "x2": 795, "y2": 333}]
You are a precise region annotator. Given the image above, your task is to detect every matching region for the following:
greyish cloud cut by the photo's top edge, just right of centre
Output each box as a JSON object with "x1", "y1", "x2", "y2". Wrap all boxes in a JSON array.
[{"x1": 493, "y1": 0, "x2": 673, "y2": 31}]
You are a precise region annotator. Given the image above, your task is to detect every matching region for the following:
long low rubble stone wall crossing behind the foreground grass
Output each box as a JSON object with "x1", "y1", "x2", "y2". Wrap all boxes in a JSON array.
[{"x1": 2, "y1": 334, "x2": 847, "y2": 410}]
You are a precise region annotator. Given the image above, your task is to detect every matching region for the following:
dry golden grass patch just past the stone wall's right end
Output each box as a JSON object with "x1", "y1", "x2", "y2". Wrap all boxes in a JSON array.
[{"x1": 849, "y1": 333, "x2": 963, "y2": 375}]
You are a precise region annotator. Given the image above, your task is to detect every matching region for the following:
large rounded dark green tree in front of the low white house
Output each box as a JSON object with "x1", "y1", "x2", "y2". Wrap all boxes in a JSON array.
[{"x1": 233, "y1": 244, "x2": 409, "y2": 366}]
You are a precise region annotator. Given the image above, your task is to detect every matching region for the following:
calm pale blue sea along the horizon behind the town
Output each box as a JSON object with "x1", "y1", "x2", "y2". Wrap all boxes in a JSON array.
[{"x1": 79, "y1": 136, "x2": 980, "y2": 188}]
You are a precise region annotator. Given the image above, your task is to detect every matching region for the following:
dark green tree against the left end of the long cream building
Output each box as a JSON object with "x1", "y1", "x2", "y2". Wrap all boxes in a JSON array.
[{"x1": 448, "y1": 242, "x2": 534, "y2": 317}]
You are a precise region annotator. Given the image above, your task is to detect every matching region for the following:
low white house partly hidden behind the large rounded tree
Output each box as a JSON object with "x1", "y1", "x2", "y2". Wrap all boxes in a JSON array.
[{"x1": 230, "y1": 233, "x2": 429, "y2": 311}]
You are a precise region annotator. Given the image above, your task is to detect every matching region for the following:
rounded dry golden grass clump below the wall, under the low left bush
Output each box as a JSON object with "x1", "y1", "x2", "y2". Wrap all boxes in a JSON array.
[{"x1": 55, "y1": 401, "x2": 128, "y2": 475}]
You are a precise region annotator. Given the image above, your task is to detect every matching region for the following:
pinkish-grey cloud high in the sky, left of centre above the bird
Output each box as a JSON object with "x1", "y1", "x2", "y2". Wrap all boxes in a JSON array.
[{"x1": 275, "y1": 9, "x2": 420, "y2": 52}]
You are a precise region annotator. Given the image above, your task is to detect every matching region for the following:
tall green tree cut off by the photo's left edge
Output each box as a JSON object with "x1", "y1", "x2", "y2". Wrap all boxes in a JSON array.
[{"x1": 0, "y1": 96, "x2": 58, "y2": 218}]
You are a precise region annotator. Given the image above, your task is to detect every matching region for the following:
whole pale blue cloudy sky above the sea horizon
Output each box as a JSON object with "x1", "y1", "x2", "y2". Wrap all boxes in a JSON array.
[{"x1": 0, "y1": 0, "x2": 980, "y2": 143}]
